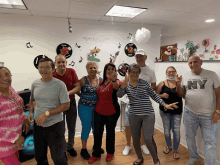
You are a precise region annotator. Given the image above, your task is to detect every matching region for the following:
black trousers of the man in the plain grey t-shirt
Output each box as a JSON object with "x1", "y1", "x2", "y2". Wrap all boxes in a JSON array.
[{"x1": 34, "y1": 121, "x2": 68, "y2": 165}]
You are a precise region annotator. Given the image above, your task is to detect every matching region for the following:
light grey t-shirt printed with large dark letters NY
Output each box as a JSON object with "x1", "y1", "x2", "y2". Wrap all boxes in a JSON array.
[{"x1": 182, "y1": 69, "x2": 220, "y2": 116}]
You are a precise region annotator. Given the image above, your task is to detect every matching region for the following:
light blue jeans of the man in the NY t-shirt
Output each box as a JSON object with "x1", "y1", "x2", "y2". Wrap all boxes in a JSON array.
[{"x1": 183, "y1": 108, "x2": 218, "y2": 165}]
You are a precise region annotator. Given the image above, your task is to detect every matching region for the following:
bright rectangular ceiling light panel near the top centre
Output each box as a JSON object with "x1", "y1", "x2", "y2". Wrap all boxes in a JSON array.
[{"x1": 105, "y1": 5, "x2": 146, "y2": 18}]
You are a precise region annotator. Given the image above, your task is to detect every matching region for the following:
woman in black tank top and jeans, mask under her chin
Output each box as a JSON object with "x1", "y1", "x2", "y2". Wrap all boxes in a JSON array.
[{"x1": 156, "y1": 66, "x2": 183, "y2": 159}]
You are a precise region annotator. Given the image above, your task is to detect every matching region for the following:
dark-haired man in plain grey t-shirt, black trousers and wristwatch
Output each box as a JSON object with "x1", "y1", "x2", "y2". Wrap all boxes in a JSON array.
[{"x1": 28, "y1": 58, "x2": 70, "y2": 165}]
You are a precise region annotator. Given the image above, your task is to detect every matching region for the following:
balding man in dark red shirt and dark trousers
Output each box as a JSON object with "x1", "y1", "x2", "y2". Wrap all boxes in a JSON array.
[{"x1": 53, "y1": 55, "x2": 81, "y2": 156}]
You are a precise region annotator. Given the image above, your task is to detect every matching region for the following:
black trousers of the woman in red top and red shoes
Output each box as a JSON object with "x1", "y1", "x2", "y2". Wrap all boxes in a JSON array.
[{"x1": 92, "y1": 110, "x2": 120, "y2": 157}]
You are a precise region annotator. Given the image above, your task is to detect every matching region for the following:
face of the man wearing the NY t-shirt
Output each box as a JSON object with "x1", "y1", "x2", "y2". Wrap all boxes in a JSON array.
[{"x1": 188, "y1": 56, "x2": 202, "y2": 74}]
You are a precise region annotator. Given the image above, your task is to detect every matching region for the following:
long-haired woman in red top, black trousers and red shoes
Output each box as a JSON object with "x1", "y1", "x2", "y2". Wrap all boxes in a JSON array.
[{"x1": 88, "y1": 63, "x2": 120, "y2": 163}]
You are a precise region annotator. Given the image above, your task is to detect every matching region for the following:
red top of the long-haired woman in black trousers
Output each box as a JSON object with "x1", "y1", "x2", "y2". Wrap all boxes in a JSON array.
[{"x1": 95, "y1": 79, "x2": 121, "y2": 116}]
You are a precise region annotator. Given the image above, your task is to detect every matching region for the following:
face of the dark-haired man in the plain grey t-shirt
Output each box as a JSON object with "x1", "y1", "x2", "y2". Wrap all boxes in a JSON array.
[{"x1": 38, "y1": 61, "x2": 55, "y2": 79}]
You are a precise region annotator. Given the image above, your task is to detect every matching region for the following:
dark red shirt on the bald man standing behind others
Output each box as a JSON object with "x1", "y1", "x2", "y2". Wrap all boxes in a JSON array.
[{"x1": 53, "y1": 68, "x2": 79, "y2": 101}]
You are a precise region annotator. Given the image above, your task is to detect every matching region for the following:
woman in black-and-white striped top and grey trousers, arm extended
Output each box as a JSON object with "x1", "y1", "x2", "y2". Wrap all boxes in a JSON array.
[{"x1": 117, "y1": 64, "x2": 177, "y2": 165}]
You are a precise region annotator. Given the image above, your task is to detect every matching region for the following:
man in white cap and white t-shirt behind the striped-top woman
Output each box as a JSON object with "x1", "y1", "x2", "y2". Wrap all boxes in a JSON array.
[{"x1": 123, "y1": 49, "x2": 156, "y2": 156}]
